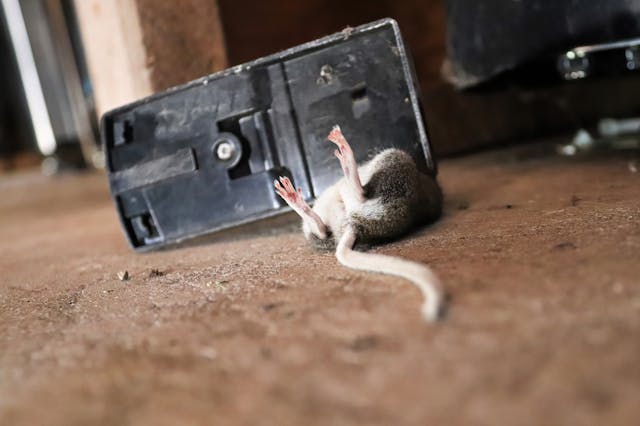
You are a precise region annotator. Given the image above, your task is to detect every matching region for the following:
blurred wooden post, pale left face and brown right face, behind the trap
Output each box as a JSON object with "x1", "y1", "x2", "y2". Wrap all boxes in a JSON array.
[{"x1": 75, "y1": 0, "x2": 227, "y2": 115}]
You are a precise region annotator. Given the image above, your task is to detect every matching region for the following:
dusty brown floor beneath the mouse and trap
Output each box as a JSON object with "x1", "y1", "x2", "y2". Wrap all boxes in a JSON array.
[{"x1": 0, "y1": 141, "x2": 640, "y2": 425}]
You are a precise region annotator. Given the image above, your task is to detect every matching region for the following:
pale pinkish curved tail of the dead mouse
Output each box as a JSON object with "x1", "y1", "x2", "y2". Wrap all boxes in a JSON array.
[{"x1": 336, "y1": 226, "x2": 443, "y2": 321}]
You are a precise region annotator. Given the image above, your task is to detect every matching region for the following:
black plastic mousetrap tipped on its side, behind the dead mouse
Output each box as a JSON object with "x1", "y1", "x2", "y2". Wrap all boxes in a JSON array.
[{"x1": 101, "y1": 19, "x2": 435, "y2": 250}]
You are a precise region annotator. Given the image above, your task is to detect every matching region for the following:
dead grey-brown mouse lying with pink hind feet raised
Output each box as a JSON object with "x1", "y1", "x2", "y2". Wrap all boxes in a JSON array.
[{"x1": 274, "y1": 126, "x2": 443, "y2": 321}]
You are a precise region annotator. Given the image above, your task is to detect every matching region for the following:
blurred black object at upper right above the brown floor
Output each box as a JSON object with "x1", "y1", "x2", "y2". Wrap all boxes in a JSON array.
[{"x1": 446, "y1": 0, "x2": 640, "y2": 88}]
